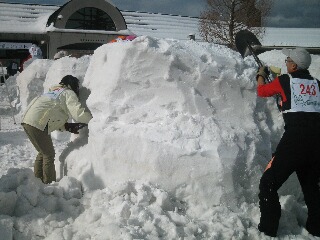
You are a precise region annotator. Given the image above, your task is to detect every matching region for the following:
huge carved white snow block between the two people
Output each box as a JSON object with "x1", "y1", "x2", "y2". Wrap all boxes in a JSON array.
[{"x1": 67, "y1": 37, "x2": 280, "y2": 210}]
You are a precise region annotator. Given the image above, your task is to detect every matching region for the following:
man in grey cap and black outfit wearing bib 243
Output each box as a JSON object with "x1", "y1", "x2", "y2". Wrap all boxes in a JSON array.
[{"x1": 257, "y1": 48, "x2": 320, "y2": 237}]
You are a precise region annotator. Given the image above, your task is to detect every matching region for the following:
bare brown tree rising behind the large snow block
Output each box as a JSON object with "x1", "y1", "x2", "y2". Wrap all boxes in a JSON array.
[{"x1": 199, "y1": 0, "x2": 274, "y2": 48}]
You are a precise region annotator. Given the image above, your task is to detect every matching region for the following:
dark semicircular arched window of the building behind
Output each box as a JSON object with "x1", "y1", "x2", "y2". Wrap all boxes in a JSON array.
[{"x1": 66, "y1": 7, "x2": 116, "y2": 31}]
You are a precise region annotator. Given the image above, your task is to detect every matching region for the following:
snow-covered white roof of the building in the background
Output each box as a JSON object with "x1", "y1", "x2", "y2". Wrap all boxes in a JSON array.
[{"x1": 0, "y1": 3, "x2": 320, "y2": 47}]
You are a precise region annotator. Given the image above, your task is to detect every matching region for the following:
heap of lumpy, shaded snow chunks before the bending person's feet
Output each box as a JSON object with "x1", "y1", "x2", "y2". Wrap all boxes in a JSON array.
[{"x1": 0, "y1": 168, "x2": 83, "y2": 239}]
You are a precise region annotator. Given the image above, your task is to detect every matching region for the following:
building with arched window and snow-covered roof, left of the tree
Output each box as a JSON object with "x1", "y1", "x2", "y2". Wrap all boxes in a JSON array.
[{"x1": 0, "y1": 0, "x2": 200, "y2": 69}]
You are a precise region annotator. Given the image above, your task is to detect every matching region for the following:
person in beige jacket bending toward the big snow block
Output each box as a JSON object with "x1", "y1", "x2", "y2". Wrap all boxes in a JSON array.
[{"x1": 22, "y1": 75, "x2": 92, "y2": 184}]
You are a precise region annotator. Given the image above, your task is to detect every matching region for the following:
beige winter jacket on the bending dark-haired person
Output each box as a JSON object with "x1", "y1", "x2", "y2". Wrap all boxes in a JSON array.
[{"x1": 22, "y1": 85, "x2": 92, "y2": 133}]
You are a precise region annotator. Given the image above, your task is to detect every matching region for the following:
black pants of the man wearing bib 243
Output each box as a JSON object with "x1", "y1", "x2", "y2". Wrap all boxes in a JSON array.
[{"x1": 259, "y1": 126, "x2": 320, "y2": 237}]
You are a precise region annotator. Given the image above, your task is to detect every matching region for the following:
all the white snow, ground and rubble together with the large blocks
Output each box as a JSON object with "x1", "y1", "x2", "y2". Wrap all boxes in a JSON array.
[{"x1": 0, "y1": 37, "x2": 320, "y2": 240}]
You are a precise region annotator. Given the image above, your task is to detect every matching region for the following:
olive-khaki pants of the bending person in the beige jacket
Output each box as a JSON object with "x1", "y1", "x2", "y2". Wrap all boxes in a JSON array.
[{"x1": 22, "y1": 123, "x2": 56, "y2": 184}]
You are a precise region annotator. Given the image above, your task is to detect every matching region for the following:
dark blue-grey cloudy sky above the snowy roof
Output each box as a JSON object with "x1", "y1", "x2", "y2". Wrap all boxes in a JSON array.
[{"x1": 0, "y1": 0, "x2": 320, "y2": 27}]
